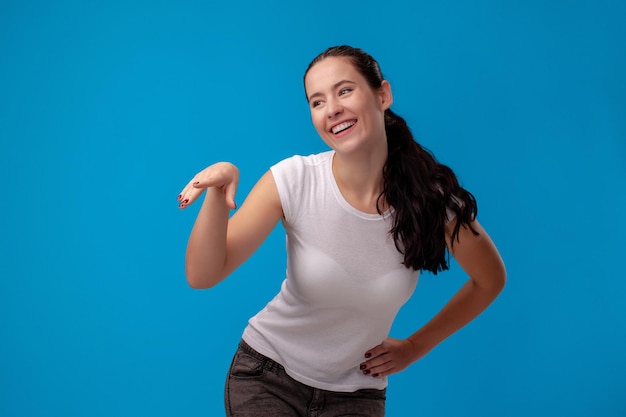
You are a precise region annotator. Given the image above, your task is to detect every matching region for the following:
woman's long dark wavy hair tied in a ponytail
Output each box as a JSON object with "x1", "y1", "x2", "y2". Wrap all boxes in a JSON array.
[{"x1": 304, "y1": 45, "x2": 478, "y2": 274}]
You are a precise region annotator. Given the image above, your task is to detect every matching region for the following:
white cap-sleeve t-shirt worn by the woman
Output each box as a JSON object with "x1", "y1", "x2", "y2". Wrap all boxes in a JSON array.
[{"x1": 243, "y1": 151, "x2": 419, "y2": 392}]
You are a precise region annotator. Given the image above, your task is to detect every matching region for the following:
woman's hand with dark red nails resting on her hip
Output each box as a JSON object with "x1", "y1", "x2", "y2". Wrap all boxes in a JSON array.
[{"x1": 360, "y1": 337, "x2": 423, "y2": 378}]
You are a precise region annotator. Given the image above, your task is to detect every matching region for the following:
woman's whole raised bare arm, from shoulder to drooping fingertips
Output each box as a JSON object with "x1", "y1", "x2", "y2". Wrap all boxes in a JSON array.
[{"x1": 179, "y1": 162, "x2": 282, "y2": 288}]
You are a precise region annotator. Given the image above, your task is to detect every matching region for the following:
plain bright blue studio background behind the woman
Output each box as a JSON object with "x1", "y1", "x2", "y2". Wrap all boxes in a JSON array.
[{"x1": 0, "y1": 0, "x2": 626, "y2": 417}]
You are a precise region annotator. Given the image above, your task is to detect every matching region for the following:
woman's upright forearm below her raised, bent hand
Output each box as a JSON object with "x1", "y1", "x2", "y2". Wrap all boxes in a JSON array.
[{"x1": 185, "y1": 187, "x2": 230, "y2": 288}]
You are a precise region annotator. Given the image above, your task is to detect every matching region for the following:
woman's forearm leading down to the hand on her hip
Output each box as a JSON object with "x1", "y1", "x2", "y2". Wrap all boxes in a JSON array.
[{"x1": 408, "y1": 279, "x2": 504, "y2": 360}]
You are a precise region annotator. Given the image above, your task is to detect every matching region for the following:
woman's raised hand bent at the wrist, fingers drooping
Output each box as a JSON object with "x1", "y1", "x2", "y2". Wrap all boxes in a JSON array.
[{"x1": 178, "y1": 162, "x2": 239, "y2": 209}]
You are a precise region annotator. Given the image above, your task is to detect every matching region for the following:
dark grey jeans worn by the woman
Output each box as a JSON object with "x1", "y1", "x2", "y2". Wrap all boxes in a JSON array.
[{"x1": 224, "y1": 340, "x2": 385, "y2": 417}]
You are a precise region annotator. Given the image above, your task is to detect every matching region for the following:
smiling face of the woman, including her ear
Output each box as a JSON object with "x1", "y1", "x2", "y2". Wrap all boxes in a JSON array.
[{"x1": 304, "y1": 57, "x2": 392, "y2": 153}]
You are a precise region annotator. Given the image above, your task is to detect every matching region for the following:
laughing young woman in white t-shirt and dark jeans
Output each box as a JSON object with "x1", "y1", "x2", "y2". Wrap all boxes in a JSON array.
[{"x1": 178, "y1": 46, "x2": 506, "y2": 416}]
